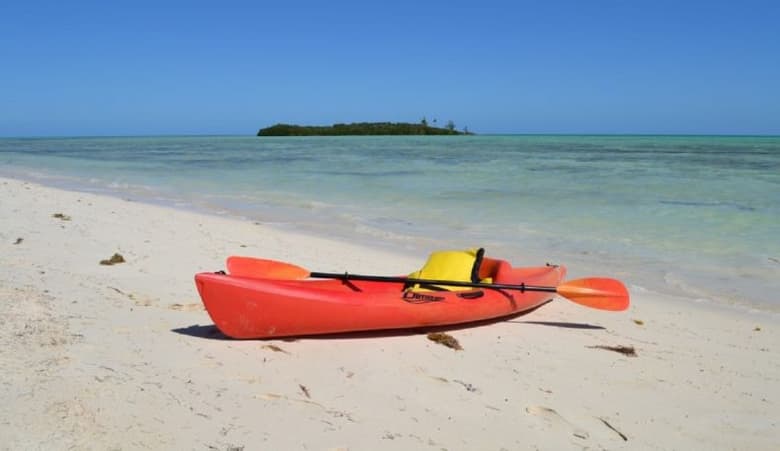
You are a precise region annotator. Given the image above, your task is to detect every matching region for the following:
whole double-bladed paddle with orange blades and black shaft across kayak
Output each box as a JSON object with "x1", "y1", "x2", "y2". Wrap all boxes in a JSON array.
[{"x1": 227, "y1": 256, "x2": 629, "y2": 311}]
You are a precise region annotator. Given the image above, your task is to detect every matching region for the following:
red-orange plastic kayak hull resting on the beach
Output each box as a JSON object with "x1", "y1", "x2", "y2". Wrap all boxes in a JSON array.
[{"x1": 195, "y1": 261, "x2": 566, "y2": 339}]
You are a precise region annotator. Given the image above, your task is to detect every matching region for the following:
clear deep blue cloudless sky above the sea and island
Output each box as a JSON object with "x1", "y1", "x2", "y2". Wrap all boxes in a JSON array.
[{"x1": 0, "y1": 0, "x2": 780, "y2": 136}]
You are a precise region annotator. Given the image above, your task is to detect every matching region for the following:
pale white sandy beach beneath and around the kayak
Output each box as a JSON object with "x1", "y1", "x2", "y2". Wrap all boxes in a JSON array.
[{"x1": 0, "y1": 178, "x2": 780, "y2": 450}]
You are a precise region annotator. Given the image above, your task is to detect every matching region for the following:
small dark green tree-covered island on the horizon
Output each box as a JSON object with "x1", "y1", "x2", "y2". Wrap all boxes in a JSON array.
[{"x1": 257, "y1": 119, "x2": 473, "y2": 136}]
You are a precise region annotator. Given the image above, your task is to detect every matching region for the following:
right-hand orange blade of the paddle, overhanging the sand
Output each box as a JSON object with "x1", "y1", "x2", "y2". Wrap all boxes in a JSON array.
[{"x1": 556, "y1": 277, "x2": 629, "y2": 311}]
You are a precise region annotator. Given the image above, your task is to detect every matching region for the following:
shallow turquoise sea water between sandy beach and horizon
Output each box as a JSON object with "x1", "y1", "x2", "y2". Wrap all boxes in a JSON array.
[{"x1": 0, "y1": 136, "x2": 780, "y2": 312}]
